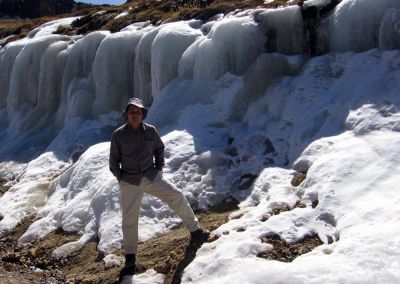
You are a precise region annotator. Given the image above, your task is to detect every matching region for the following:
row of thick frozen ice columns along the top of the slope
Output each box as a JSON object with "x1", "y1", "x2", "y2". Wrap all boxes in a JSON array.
[{"x1": 0, "y1": 0, "x2": 400, "y2": 149}]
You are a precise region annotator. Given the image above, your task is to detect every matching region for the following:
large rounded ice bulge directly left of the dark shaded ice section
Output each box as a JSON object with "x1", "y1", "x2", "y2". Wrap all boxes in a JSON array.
[{"x1": 180, "y1": 17, "x2": 265, "y2": 79}]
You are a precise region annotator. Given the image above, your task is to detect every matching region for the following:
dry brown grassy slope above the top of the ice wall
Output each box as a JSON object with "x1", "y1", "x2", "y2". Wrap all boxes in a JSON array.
[{"x1": 0, "y1": 0, "x2": 300, "y2": 45}]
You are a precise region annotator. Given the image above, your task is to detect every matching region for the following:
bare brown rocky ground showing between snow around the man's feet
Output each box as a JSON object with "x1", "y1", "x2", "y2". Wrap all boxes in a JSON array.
[{"x1": 0, "y1": 175, "x2": 322, "y2": 284}]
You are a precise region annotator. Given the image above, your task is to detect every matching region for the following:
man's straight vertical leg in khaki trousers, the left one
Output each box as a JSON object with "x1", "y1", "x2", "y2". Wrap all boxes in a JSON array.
[{"x1": 119, "y1": 181, "x2": 143, "y2": 255}]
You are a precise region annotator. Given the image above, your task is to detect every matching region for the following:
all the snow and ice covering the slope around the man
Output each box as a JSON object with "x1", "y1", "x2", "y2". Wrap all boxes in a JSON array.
[{"x1": 0, "y1": 0, "x2": 400, "y2": 283}]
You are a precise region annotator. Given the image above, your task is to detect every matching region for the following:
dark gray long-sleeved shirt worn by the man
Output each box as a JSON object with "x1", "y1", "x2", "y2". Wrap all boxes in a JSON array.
[{"x1": 109, "y1": 123, "x2": 164, "y2": 185}]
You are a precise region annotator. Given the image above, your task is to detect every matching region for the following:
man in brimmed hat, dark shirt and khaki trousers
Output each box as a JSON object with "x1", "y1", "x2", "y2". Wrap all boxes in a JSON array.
[{"x1": 110, "y1": 98, "x2": 210, "y2": 275}]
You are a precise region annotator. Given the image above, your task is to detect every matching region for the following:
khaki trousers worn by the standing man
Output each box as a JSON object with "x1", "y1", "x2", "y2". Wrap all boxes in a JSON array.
[{"x1": 119, "y1": 172, "x2": 199, "y2": 254}]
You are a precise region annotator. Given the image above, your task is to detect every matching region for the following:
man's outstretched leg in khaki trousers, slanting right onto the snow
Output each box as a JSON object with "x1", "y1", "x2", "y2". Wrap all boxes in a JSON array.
[{"x1": 140, "y1": 173, "x2": 200, "y2": 232}]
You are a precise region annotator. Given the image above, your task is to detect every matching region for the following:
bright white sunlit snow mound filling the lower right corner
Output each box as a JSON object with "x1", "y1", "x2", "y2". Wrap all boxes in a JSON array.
[{"x1": 183, "y1": 131, "x2": 400, "y2": 283}]
